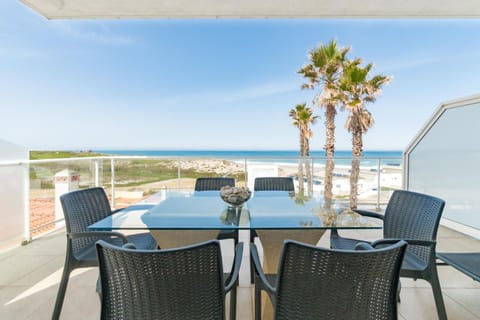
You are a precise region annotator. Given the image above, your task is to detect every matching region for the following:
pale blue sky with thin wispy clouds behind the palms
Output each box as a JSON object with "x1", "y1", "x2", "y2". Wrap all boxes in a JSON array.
[{"x1": 0, "y1": 0, "x2": 480, "y2": 150}]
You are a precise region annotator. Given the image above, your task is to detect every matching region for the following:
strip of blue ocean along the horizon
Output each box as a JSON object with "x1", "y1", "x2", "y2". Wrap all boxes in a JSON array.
[{"x1": 93, "y1": 150, "x2": 402, "y2": 167}]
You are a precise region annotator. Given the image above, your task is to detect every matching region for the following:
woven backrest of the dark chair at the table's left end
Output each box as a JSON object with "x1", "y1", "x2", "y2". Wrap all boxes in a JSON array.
[{"x1": 60, "y1": 187, "x2": 112, "y2": 255}]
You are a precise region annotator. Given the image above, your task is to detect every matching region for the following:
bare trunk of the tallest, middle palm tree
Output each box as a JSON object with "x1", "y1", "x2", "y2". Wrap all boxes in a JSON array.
[{"x1": 323, "y1": 104, "x2": 337, "y2": 209}]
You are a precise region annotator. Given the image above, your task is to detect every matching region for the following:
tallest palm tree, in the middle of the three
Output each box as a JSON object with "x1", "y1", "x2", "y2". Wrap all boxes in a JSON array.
[{"x1": 298, "y1": 40, "x2": 350, "y2": 208}]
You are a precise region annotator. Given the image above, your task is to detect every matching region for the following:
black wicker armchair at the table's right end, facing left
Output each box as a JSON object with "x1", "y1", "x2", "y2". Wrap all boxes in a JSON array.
[{"x1": 330, "y1": 190, "x2": 447, "y2": 320}]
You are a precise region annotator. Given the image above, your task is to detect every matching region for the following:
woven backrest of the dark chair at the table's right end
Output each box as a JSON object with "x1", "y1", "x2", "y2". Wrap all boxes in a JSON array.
[{"x1": 383, "y1": 190, "x2": 445, "y2": 264}]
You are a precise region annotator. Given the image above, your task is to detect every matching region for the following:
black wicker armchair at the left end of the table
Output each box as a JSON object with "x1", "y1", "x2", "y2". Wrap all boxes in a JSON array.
[{"x1": 52, "y1": 188, "x2": 157, "y2": 319}]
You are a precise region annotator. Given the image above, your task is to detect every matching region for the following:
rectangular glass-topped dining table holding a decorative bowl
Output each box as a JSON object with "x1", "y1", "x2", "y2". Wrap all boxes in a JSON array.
[{"x1": 88, "y1": 190, "x2": 382, "y2": 319}]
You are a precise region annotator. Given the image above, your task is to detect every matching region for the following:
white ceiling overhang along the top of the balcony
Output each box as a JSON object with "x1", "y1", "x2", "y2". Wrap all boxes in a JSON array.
[{"x1": 19, "y1": 0, "x2": 480, "y2": 19}]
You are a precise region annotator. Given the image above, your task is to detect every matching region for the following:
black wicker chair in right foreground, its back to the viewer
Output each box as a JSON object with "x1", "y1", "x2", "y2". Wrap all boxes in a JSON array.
[{"x1": 251, "y1": 240, "x2": 407, "y2": 320}]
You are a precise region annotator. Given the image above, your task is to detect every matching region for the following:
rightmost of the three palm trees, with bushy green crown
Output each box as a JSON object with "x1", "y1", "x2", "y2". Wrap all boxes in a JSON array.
[{"x1": 340, "y1": 59, "x2": 391, "y2": 209}]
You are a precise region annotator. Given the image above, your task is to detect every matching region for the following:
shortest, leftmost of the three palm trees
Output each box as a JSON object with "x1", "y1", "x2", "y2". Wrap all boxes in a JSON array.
[{"x1": 289, "y1": 103, "x2": 318, "y2": 195}]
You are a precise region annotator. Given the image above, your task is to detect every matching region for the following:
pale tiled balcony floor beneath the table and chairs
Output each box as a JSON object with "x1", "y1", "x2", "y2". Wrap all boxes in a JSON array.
[{"x1": 0, "y1": 227, "x2": 480, "y2": 320}]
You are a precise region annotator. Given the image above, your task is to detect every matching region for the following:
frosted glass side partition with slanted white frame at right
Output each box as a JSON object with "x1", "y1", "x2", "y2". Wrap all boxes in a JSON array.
[{"x1": 405, "y1": 95, "x2": 480, "y2": 238}]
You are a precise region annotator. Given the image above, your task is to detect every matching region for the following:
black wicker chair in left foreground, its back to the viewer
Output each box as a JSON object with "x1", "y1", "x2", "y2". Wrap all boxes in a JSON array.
[{"x1": 97, "y1": 240, "x2": 243, "y2": 320}]
